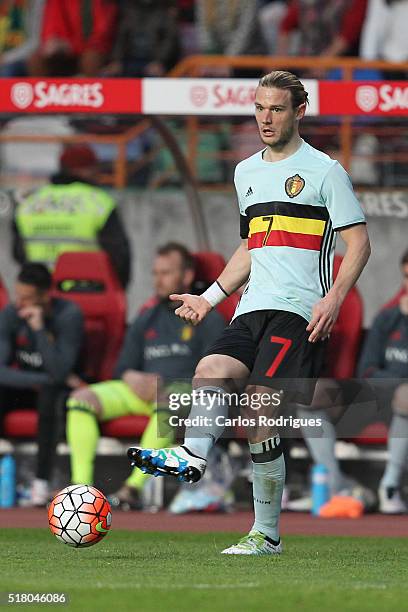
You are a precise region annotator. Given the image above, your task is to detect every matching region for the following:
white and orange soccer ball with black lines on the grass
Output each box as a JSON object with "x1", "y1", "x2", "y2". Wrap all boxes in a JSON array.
[{"x1": 48, "y1": 485, "x2": 112, "y2": 548}]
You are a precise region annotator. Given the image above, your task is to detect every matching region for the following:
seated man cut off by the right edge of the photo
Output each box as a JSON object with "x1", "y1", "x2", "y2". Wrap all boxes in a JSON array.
[{"x1": 359, "y1": 251, "x2": 408, "y2": 514}]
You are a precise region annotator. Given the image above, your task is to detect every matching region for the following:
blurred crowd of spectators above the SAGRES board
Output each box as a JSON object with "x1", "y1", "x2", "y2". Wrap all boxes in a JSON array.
[{"x1": 0, "y1": 0, "x2": 408, "y2": 77}]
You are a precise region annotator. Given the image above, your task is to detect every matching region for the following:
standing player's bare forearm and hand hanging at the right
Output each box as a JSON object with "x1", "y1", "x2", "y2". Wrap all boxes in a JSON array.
[{"x1": 306, "y1": 225, "x2": 371, "y2": 342}]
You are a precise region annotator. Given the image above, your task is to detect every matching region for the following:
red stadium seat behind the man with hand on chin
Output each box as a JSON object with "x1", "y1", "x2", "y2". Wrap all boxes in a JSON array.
[{"x1": 53, "y1": 252, "x2": 126, "y2": 380}]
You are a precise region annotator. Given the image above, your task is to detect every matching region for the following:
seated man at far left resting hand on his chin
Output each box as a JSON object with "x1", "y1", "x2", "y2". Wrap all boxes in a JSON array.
[{"x1": 0, "y1": 263, "x2": 83, "y2": 505}]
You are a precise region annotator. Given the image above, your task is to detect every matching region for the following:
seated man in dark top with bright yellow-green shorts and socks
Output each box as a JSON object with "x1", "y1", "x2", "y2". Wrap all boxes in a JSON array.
[{"x1": 67, "y1": 243, "x2": 225, "y2": 509}]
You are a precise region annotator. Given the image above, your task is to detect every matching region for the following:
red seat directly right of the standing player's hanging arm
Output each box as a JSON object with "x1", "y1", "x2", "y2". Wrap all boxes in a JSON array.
[{"x1": 326, "y1": 255, "x2": 363, "y2": 379}]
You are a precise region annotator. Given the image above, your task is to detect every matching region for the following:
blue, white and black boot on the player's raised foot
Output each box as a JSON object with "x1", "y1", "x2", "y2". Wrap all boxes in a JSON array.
[{"x1": 127, "y1": 446, "x2": 207, "y2": 482}]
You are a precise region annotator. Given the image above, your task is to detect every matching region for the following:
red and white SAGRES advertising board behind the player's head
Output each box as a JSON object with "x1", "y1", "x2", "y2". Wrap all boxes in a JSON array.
[{"x1": 0, "y1": 78, "x2": 408, "y2": 116}]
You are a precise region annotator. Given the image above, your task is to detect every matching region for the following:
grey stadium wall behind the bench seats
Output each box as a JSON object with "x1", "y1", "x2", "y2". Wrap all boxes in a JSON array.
[{"x1": 0, "y1": 189, "x2": 408, "y2": 327}]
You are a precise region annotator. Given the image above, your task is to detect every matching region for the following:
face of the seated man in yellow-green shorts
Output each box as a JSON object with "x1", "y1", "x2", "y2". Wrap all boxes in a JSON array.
[{"x1": 153, "y1": 251, "x2": 192, "y2": 300}]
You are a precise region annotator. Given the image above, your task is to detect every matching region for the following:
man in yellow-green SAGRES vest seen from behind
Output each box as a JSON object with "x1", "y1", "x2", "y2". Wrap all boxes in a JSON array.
[{"x1": 12, "y1": 144, "x2": 131, "y2": 288}]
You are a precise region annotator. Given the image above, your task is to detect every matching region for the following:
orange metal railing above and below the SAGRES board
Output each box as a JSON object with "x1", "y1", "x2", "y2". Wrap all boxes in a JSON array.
[{"x1": 0, "y1": 55, "x2": 408, "y2": 189}]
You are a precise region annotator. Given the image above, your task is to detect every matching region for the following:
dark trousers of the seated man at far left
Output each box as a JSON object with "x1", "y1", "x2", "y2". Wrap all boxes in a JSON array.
[{"x1": 0, "y1": 385, "x2": 68, "y2": 480}]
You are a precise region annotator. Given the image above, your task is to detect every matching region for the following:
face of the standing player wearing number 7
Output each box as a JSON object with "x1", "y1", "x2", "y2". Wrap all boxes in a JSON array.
[{"x1": 255, "y1": 87, "x2": 305, "y2": 150}]
